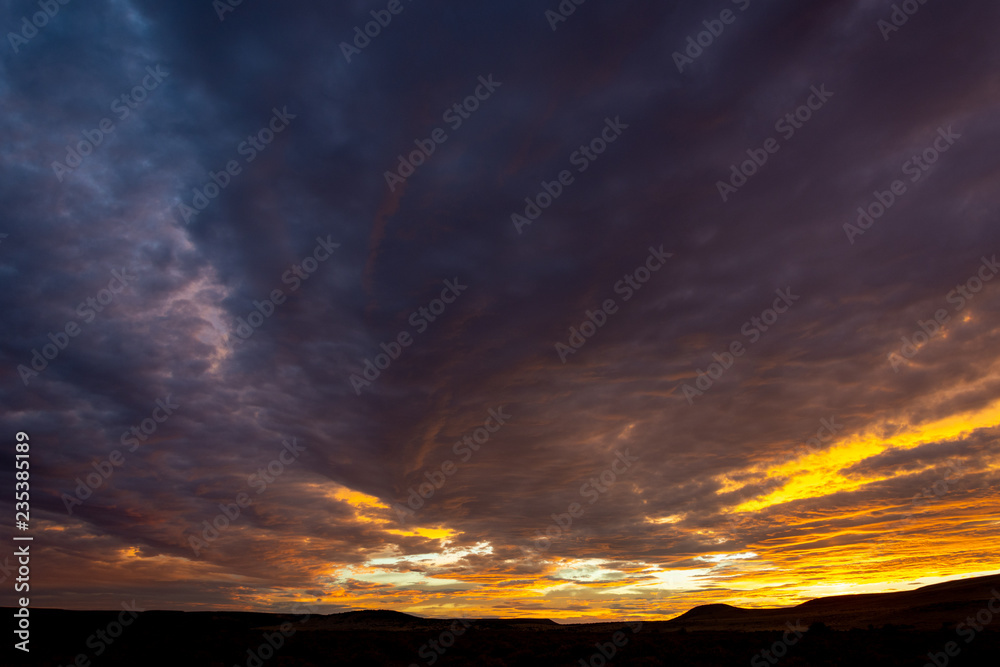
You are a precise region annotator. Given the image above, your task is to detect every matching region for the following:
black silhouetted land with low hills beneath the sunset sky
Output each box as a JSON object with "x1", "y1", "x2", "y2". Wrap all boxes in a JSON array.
[{"x1": 4, "y1": 576, "x2": 1000, "y2": 667}]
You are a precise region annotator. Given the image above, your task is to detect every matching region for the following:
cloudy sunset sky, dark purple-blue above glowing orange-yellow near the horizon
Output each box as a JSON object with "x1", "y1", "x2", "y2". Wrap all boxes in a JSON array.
[{"x1": 0, "y1": 0, "x2": 1000, "y2": 622}]
